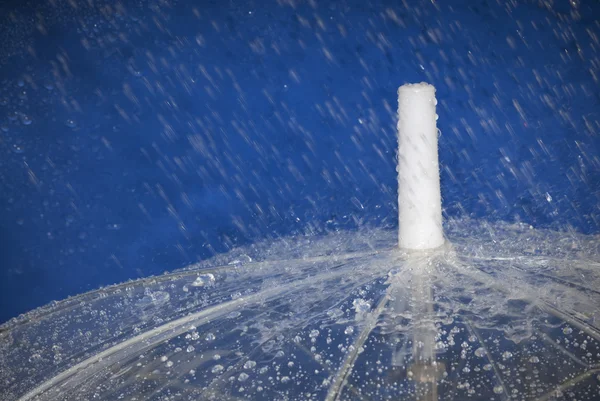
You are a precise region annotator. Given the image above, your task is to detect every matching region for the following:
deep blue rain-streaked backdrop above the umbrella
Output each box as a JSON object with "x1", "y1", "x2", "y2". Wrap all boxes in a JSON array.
[{"x1": 0, "y1": 0, "x2": 600, "y2": 322}]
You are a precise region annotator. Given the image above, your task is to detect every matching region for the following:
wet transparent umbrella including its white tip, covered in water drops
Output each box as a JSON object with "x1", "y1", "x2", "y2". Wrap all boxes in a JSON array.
[{"x1": 0, "y1": 84, "x2": 600, "y2": 400}]
